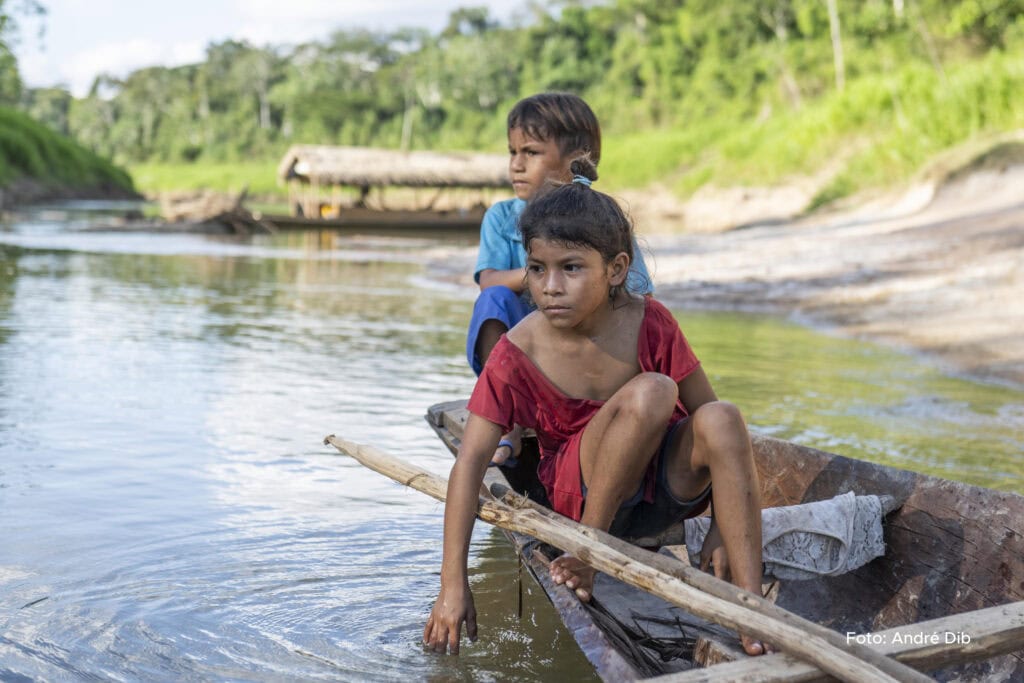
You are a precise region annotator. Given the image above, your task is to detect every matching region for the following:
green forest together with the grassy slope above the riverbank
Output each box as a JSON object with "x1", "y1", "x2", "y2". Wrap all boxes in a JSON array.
[{"x1": 0, "y1": 0, "x2": 1024, "y2": 204}]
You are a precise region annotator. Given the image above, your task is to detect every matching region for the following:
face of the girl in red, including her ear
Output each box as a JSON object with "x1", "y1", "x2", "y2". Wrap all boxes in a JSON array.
[{"x1": 526, "y1": 238, "x2": 630, "y2": 328}]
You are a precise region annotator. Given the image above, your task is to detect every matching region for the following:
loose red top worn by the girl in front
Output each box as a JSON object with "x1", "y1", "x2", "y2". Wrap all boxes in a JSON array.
[{"x1": 469, "y1": 297, "x2": 699, "y2": 521}]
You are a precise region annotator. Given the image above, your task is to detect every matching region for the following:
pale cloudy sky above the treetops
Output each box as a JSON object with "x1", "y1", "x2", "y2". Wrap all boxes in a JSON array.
[{"x1": 14, "y1": 0, "x2": 526, "y2": 97}]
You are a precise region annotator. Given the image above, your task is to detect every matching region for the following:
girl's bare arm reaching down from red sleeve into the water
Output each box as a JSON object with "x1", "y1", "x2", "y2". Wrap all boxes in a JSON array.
[{"x1": 423, "y1": 414, "x2": 502, "y2": 654}]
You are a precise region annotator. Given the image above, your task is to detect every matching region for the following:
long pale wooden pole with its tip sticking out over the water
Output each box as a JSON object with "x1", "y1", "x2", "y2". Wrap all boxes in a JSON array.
[{"x1": 324, "y1": 435, "x2": 931, "y2": 683}]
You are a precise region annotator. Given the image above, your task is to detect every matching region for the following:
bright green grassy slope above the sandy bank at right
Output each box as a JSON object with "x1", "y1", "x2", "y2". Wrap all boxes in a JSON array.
[{"x1": 601, "y1": 49, "x2": 1024, "y2": 208}]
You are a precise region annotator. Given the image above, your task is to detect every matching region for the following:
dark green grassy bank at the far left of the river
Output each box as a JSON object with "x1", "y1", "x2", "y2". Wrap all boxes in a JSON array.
[{"x1": 0, "y1": 106, "x2": 133, "y2": 191}]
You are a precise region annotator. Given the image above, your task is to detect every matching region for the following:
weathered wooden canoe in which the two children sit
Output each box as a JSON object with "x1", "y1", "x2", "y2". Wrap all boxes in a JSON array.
[{"x1": 427, "y1": 401, "x2": 1024, "y2": 680}]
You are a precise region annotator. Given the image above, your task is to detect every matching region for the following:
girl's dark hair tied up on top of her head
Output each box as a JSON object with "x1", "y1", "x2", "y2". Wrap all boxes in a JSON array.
[{"x1": 519, "y1": 157, "x2": 634, "y2": 278}]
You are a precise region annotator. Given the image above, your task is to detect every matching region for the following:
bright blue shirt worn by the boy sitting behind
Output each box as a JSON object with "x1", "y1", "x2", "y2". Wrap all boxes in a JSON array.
[{"x1": 473, "y1": 198, "x2": 654, "y2": 294}]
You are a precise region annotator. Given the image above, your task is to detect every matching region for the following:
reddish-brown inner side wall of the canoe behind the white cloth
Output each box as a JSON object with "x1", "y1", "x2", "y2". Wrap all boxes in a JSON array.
[{"x1": 754, "y1": 436, "x2": 1024, "y2": 633}]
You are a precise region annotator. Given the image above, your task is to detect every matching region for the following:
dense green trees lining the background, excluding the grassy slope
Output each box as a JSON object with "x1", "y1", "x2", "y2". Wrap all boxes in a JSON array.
[{"x1": 9, "y1": 0, "x2": 1024, "y2": 161}]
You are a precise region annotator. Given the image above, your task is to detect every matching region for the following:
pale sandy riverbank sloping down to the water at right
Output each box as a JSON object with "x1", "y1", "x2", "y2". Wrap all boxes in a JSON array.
[{"x1": 631, "y1": 165, "x2": 1024, "y2": 385}]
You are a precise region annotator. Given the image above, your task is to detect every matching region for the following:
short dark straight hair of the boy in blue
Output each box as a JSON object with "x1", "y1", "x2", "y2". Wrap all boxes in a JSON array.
[{"x1": 508, "y1": 92, "x2": 601, "y2": 169}]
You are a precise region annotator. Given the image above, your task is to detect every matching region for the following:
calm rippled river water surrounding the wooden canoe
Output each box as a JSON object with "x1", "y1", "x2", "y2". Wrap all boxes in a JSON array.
[{"x1": 0, "y1": 203, "x2": 1024, "y2": 681}]
